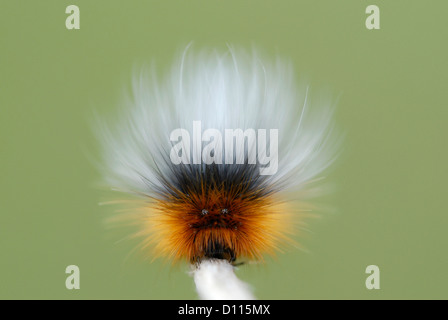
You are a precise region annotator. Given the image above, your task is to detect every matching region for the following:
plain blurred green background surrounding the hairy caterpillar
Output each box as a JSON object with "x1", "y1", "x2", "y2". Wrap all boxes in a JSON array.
[{"x1": 0, "y1": 0, "x2": 448, "y2": 299}]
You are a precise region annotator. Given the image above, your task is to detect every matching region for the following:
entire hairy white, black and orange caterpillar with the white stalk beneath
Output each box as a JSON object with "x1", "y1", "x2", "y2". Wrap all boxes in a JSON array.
[{"x1": 95, "y1": 46, "x2": 339, "y2": 299}]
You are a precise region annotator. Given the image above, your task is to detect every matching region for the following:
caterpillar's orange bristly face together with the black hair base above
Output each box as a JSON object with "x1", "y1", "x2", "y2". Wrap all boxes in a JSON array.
[{"x1": 149, "y1": 164, "x2": 289, "y2": 263}]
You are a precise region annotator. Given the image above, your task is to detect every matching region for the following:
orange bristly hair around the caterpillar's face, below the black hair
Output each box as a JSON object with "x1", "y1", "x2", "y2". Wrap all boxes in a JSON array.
[{"x1": 141, "y1": 190, "x2": 292, "y2": 263}]
